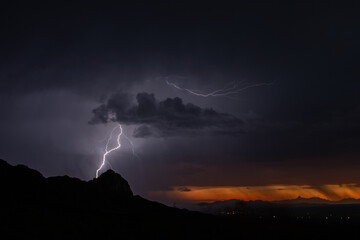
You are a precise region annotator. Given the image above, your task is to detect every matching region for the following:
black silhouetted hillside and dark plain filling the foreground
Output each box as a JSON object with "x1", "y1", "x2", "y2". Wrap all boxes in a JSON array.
[{"x1": 0, "y1": 160, "x2": 360, "y2": 239}]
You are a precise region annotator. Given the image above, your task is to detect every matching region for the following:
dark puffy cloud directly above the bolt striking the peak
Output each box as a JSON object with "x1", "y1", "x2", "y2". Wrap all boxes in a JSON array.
[{"x1": 90, "y1": 92, "x2": 243, "y2": 137}]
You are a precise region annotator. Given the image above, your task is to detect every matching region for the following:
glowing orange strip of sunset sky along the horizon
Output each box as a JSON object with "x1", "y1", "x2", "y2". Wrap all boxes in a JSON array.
[{"x1": 150, "y1": 183, "x2": 360, "y2": 202}]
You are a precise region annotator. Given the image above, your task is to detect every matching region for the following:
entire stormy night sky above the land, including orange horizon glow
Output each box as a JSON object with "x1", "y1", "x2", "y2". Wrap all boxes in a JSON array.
[{"x1": 0, "y1": 1, "x2": 360, "y2": 203}]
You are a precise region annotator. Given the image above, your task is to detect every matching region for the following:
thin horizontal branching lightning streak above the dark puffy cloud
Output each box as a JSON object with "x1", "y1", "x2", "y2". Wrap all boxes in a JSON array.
[{"x1": 166, "y1": 80, "x2": 273, "y2": 97}]
